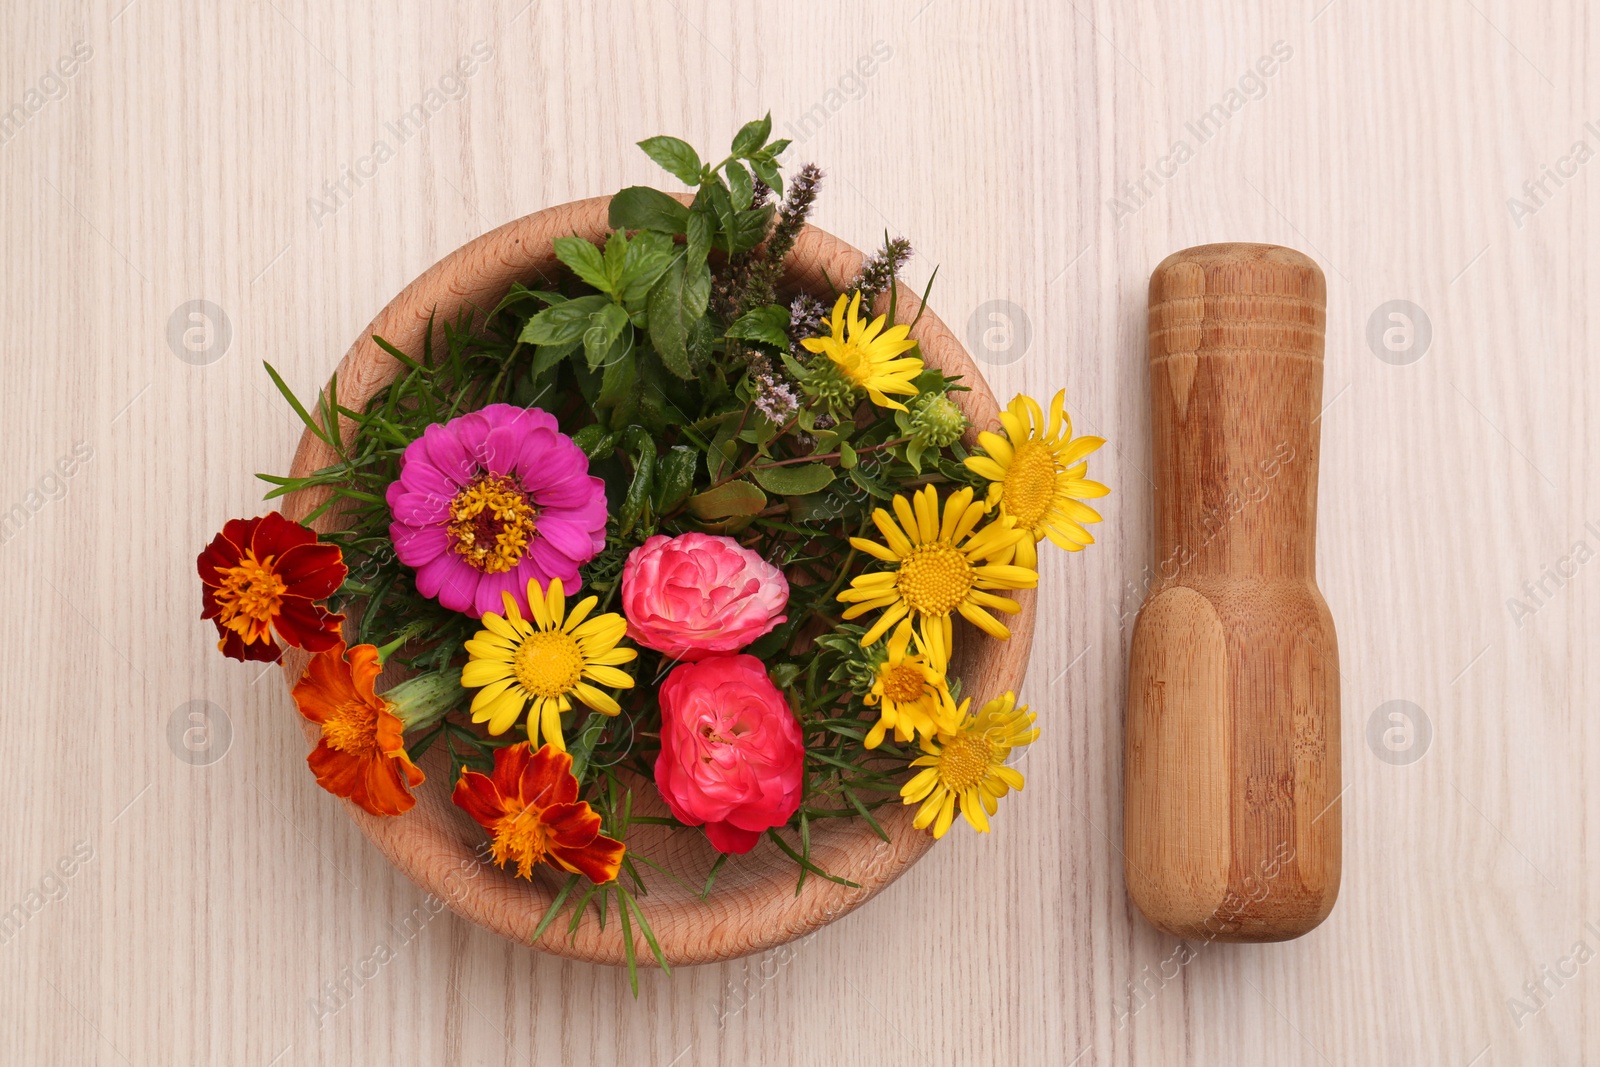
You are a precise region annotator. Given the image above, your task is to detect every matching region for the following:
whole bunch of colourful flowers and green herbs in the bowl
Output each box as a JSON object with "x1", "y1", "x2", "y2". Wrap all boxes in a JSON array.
[{"x1": 198, "y1": 117, "x2": 1107, "y2": 965}]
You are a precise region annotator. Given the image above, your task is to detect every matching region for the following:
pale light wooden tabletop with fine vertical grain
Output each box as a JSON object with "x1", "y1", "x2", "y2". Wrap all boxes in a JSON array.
[{"x1": 0, "y1": 0, "x2": 1600, "y2": 1067}]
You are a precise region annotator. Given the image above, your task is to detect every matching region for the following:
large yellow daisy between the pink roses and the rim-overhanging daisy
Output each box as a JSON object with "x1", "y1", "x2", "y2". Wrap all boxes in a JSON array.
[{"x1": 838, "y1": 485, "x2": 1038, "y2": 648}]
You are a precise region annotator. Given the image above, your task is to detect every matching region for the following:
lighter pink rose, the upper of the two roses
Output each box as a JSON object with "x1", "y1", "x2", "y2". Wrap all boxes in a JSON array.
[{"x1": 622, "y1": 533, "x2": 789, "y2": 662}]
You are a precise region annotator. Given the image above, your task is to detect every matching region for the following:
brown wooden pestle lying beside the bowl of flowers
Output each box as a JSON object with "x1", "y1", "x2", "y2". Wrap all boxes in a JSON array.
[{"x1": 1123, "y1": 245, "x2": 1341, "y2": 941}]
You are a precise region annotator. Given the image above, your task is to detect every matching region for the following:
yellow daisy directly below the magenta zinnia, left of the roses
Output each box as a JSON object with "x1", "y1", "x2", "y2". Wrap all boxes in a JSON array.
[{"x1": 461, "y1": 577, "x2": 638, "y2": 752}]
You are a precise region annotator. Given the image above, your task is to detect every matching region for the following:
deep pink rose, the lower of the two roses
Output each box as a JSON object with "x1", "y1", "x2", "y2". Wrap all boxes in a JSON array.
[{"x1": 656, "y1": 655, "x2": 805, "y2": 854}]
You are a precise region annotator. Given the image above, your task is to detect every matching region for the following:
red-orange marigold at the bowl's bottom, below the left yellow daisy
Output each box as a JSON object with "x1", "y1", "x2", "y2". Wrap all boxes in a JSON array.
[{"x1": 453, "y1": 742, "x2": 626, "y2": 883}]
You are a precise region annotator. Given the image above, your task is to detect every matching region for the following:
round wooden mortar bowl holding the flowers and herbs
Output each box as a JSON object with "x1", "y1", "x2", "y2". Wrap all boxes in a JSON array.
[{"x1": 283, "y1": 197, "x2": 1034, "y2": 966}]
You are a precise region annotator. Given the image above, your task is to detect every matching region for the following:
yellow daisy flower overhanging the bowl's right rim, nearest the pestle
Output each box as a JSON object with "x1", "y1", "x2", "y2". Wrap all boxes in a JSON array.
[{"x1": 966, "y1": 389, "x2": 1110, "y2": 568}]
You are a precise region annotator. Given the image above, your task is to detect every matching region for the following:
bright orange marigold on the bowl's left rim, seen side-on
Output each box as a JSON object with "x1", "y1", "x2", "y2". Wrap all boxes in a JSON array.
[{"x1": 294, "y1": 641, "x2": 422, "y2": 816}]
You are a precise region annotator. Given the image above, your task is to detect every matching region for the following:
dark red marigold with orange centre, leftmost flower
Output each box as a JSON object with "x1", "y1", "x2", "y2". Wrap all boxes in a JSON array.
[{"x1": 195, "y1": 512, "x2": 347, "y2": 661}]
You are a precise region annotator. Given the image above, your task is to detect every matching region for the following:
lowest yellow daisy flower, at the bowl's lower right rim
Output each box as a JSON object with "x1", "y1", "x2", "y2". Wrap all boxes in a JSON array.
[{"x1": 901, "y1": 693, "x2": 1038, "y2": 838}]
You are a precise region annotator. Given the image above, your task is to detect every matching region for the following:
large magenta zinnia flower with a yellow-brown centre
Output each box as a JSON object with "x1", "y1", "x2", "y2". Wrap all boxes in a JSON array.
[{"x1": 387, "y1": 403, "x2": 605, "y2": 619}]
